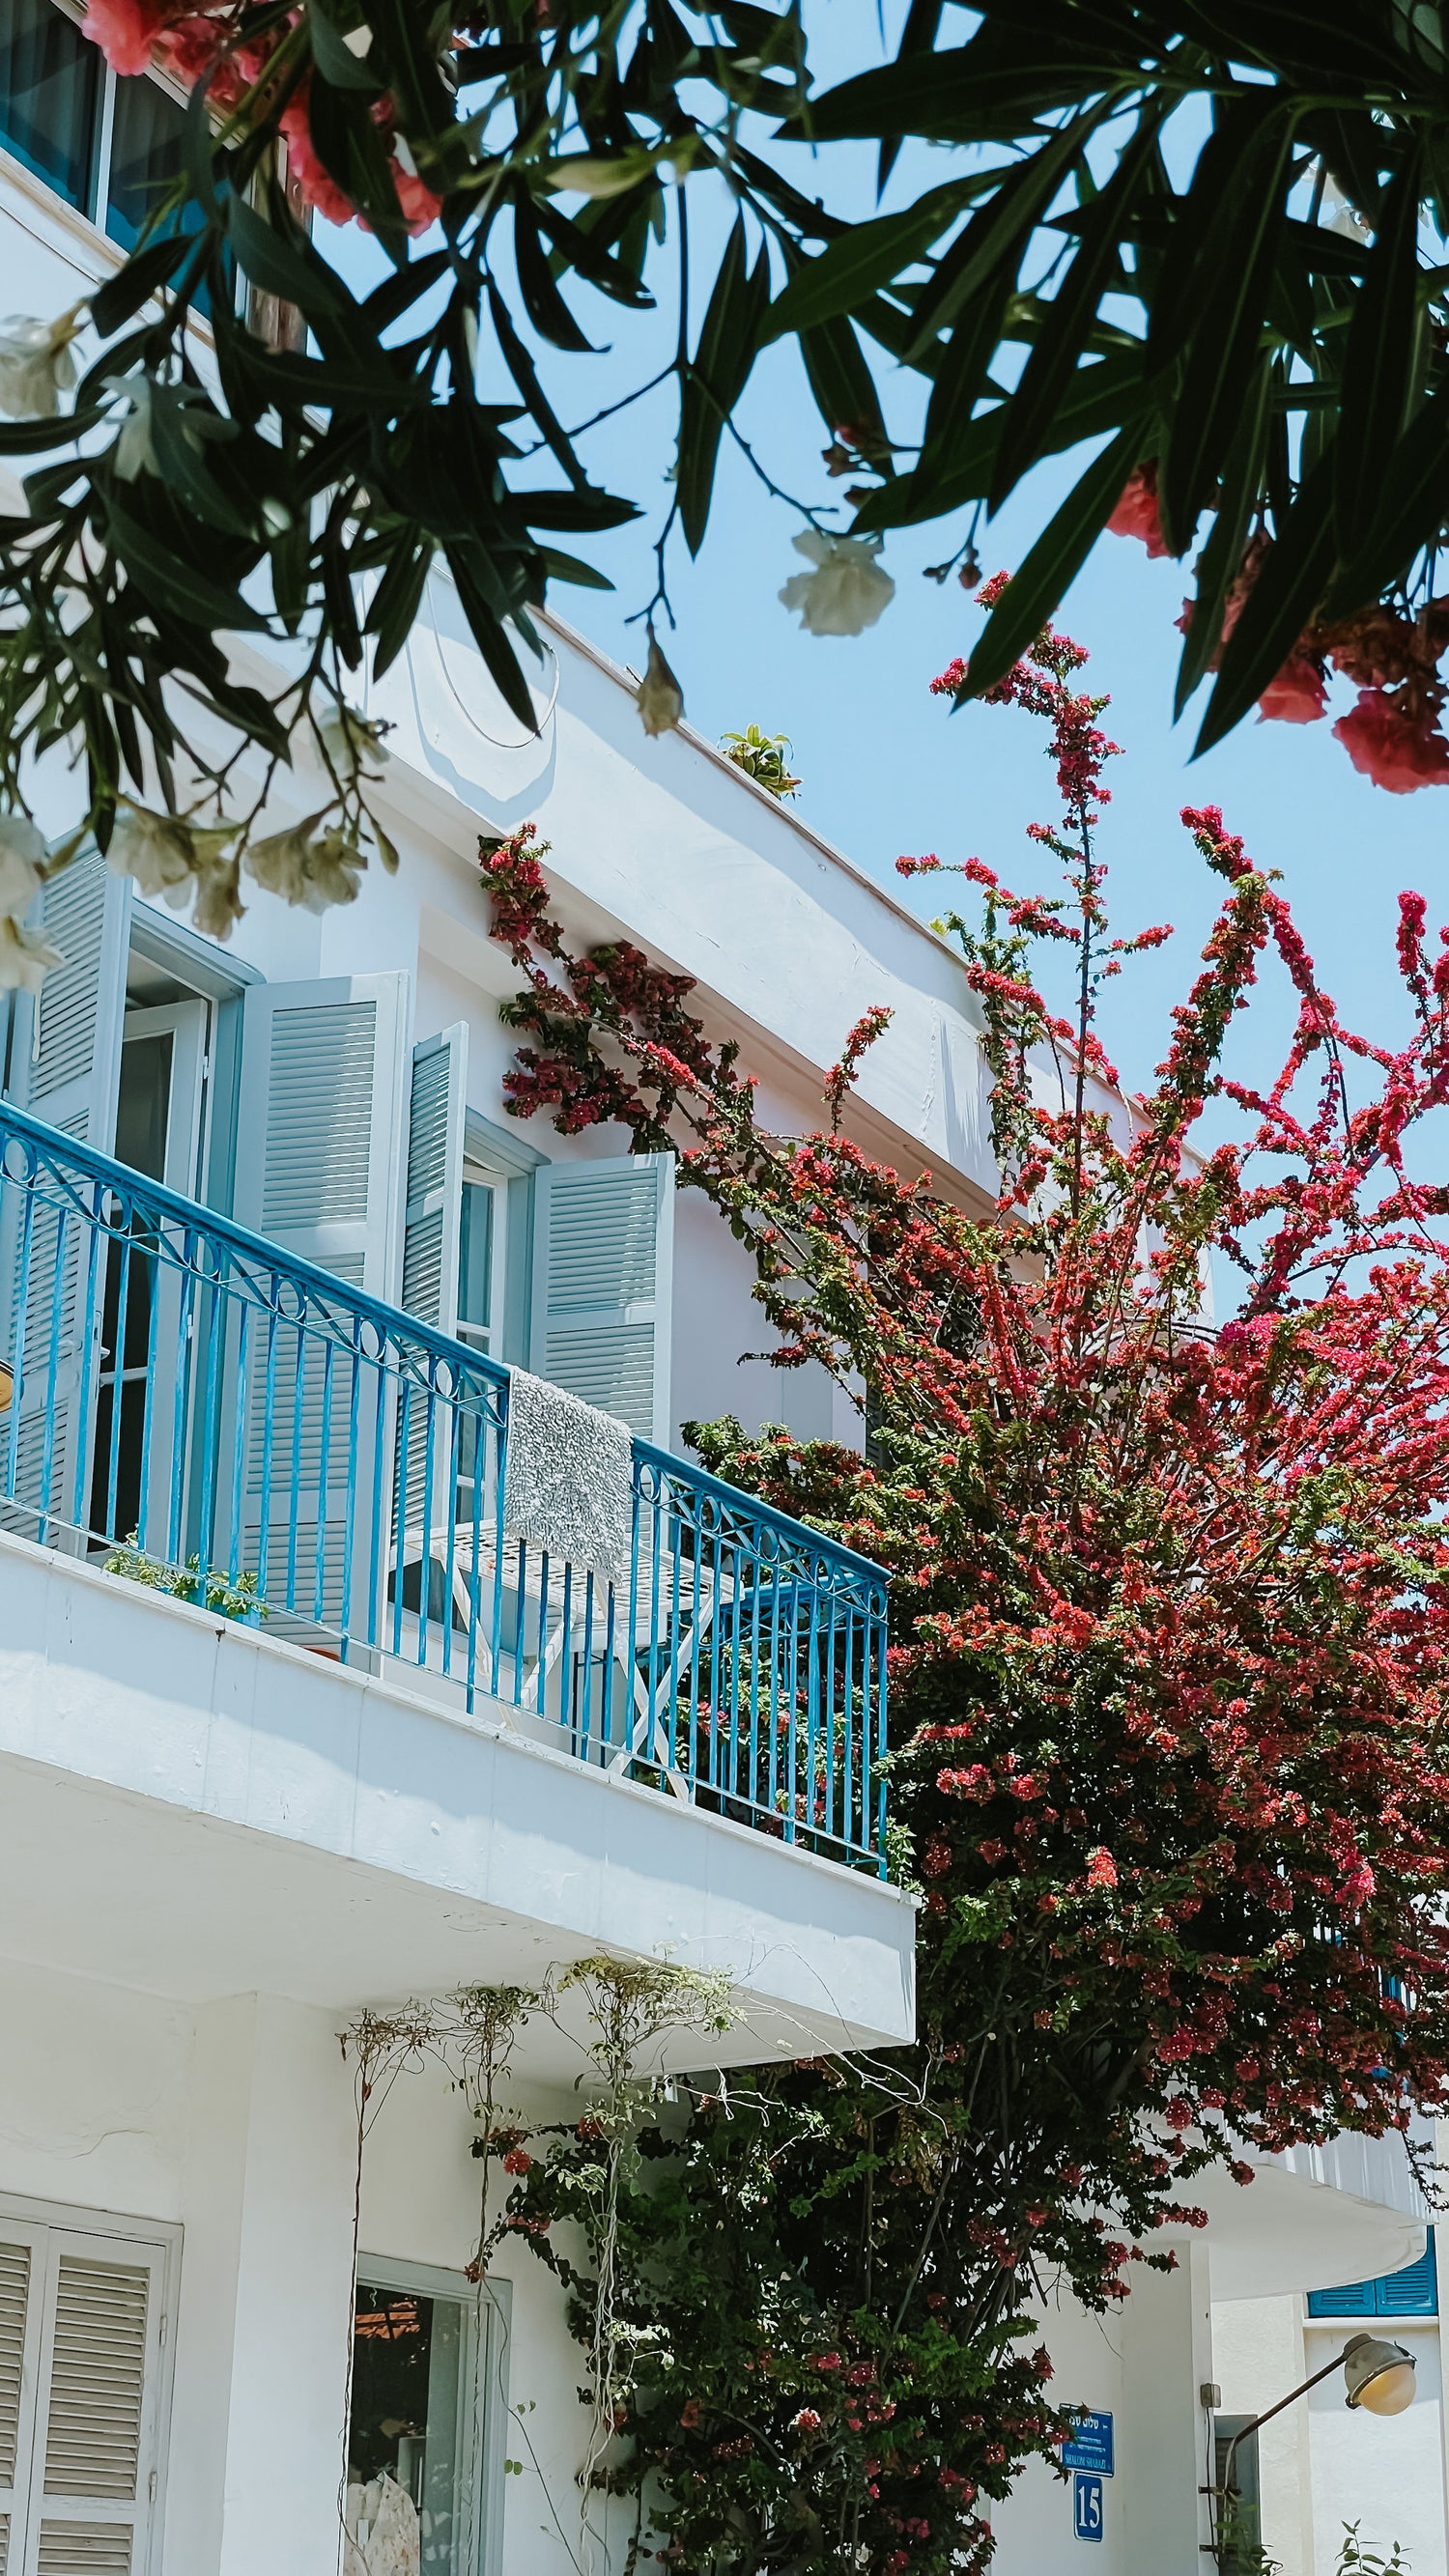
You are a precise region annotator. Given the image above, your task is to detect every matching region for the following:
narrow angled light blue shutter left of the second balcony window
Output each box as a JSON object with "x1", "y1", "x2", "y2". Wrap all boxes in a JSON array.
[{"x1": 394, "y1": 1020, "x2": 467, "y2": 1533}]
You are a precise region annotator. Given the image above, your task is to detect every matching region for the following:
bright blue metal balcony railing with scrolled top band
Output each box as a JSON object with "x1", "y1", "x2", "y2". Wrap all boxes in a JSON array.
[{"x1": 0, "y1": 1102, "x2": 884, "y2": 1876}]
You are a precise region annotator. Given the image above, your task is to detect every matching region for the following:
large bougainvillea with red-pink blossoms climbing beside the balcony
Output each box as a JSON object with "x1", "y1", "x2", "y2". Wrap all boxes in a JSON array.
[{"x1": 474, "y1": 597, "x2": 1449, "y2": 2576}]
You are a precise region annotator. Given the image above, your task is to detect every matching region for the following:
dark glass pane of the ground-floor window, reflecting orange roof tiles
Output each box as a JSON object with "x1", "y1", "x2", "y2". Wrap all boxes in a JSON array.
[{"x1": 346, "y1": 2279, "x2": 469, "y2": 2576}]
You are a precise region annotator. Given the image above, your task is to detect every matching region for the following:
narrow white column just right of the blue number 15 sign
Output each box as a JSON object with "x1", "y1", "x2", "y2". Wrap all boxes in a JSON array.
[{"x1": 1117, "y1": 2241, "x2": 1211, "y2": 2576}]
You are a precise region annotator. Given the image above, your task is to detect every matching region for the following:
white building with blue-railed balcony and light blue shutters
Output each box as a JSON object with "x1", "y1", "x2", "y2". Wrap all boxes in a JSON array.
[{"x1": 0, "y1": 0, "x2": 1426, "y2": 2576}]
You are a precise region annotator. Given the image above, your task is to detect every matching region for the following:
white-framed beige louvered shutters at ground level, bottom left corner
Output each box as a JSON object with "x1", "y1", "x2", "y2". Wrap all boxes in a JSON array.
[{"x1": 0, "y1": 2213, "x2": 167, "y2": 2576}]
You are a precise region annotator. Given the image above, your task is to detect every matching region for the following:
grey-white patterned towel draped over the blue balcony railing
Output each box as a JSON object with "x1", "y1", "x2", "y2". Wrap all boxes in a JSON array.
[{"x1": 502, "y1": 1368, "x2": 635, "y2": 1584}]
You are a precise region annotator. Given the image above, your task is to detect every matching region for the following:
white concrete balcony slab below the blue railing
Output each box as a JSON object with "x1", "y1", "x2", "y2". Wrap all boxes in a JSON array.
[{"x1": 0, "y1": 1536, "x2": 916, "y2": 2079}]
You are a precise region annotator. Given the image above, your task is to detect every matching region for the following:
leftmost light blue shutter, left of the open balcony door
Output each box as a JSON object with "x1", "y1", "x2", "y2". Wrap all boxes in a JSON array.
[{"x1": 0, "y1": 850, "x2": 131, "y2": 1541}]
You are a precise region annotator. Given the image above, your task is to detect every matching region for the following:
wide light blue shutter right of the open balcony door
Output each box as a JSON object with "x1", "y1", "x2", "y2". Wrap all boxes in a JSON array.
[{"x1": 224, "y1": 974, "x2": 408, "y2": 1633}]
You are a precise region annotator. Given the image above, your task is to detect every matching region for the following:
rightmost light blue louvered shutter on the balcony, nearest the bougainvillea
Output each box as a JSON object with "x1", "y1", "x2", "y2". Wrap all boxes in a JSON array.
[{"x1": 528, "y1": 1154, "x2": 673, "y2": 1445}]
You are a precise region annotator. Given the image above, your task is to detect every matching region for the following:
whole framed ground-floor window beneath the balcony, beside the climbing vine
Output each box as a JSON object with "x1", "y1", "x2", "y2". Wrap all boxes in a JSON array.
[{"x1": 343, "y1": 2259, "x2": 510, "y2": 2576}]
